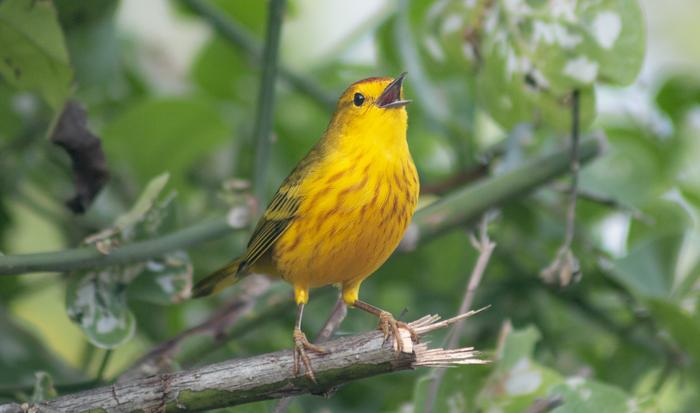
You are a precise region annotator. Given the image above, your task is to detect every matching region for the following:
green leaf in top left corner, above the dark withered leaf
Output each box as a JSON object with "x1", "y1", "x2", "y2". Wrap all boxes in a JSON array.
[{"x1": 0, "y1": 0, "x2": 73, "y2": 111}]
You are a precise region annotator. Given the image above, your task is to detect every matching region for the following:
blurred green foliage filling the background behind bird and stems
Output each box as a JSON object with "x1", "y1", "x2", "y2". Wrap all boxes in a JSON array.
[{"x1": 0, "y1": 0, "x2": 700, "y2": 412}]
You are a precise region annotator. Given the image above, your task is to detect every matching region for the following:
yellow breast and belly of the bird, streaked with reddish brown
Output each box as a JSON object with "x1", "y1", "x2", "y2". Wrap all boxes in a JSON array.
[{"x1": 273, "y1": 147, "x2": 419, "y2": 288}]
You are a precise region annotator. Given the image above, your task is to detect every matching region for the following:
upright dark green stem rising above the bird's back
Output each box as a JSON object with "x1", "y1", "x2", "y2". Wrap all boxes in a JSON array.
[{"x1": 253, "y1": 0, "x2": 286, "y2": 205}]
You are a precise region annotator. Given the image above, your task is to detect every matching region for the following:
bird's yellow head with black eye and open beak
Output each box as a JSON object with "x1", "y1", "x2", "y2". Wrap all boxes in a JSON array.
[{"x1": 330, "y1": 73, "x2": 410, "y2": 148}]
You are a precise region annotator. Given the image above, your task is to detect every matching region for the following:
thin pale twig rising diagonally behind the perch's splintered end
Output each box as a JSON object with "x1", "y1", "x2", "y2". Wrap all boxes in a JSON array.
[{"x1": 423, "y1": 217, "x2": 496, "y2": 412}]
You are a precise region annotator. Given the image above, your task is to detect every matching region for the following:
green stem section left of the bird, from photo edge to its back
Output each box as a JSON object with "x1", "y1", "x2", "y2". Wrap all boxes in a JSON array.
[{"x1": 0, "y1": 217, "x2": 233, "y2": 275}]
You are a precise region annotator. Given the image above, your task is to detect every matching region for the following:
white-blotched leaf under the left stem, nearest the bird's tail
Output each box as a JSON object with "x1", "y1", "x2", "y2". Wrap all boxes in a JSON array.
[{"x1": 127, "y1": 251, "x2": 192, "y2": 305}]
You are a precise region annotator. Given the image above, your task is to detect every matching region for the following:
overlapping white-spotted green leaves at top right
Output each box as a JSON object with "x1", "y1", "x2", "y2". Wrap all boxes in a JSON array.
[{"x1": 464, "y1": 0, "x2": 644, "y2": 129}]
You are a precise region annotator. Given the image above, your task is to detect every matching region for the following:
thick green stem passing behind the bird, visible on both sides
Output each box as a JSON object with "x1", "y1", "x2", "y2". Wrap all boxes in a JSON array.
[{"x1": 0, "y1": 139, "x2": 604, "y2": 275}]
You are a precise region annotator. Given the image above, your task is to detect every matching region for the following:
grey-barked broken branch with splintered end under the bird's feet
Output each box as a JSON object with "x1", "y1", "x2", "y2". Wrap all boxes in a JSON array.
[{"x1": 0, "y1": 312, "x2": 485, "y2": 413}]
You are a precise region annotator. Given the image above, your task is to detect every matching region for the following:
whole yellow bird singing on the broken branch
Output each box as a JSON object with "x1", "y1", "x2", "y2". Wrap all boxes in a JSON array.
[{"x1": 193, "y1": 73, "x2": 419, "y2": 380}]
